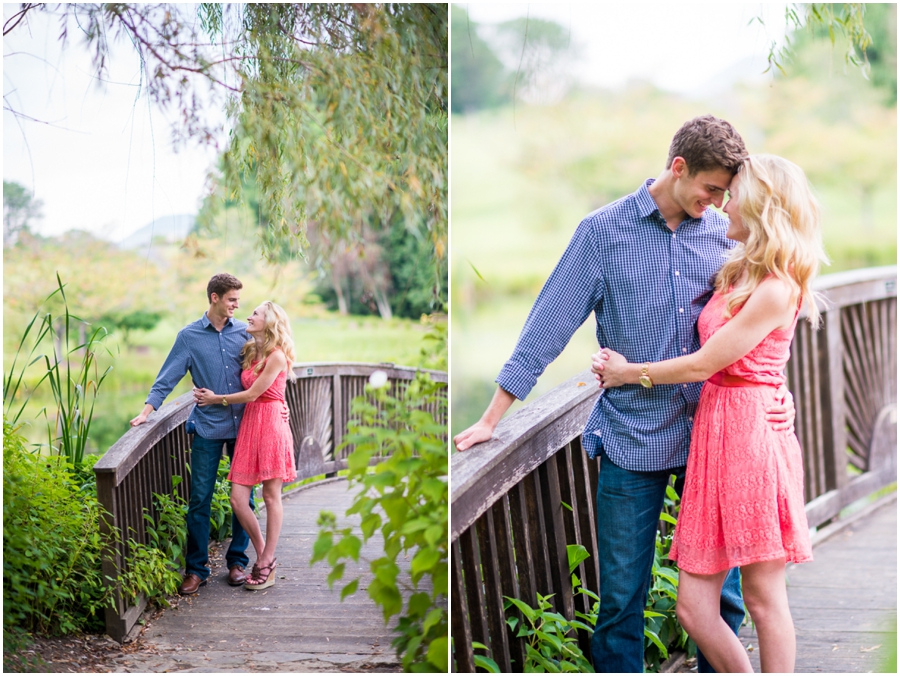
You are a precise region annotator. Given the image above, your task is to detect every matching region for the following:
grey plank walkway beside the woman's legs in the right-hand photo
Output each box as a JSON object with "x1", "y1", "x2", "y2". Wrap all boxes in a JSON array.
[{"x1": 741, "y1": 494, "x2": 897, "y2": 674}]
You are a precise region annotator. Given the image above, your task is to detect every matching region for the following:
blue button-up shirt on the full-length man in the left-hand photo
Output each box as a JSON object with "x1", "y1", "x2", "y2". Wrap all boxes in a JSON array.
[{"x1": 146, "y1": 313, "x2": 250, "y2": 439}]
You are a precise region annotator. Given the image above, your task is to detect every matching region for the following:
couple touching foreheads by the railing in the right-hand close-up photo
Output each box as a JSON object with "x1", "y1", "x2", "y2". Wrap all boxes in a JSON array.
[{"x1": 454, "y1": 115, "x2": 826, "y2": 672}]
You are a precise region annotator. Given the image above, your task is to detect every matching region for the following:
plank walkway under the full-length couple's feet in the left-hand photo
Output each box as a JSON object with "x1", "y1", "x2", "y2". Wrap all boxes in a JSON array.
[{"x1": 111, "y1": 479, "x2": 400, "y2": 673}]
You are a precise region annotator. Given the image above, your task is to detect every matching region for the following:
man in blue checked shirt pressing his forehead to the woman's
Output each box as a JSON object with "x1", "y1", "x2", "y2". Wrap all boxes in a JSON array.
[{"x1": 454, "y1": 115, "x2": 793, "y2": 672}]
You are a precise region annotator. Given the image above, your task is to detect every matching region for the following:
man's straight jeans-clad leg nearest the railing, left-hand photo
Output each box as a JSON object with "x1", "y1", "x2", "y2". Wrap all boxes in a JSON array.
[{"x1": 185, "y1": 434, "x2": 225, "y2": 580}]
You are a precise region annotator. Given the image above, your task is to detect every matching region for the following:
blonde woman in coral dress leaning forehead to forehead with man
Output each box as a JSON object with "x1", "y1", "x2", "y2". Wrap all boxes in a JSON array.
[{"x1": 592, "y1": 155, "x2": 827, "y2": 672}]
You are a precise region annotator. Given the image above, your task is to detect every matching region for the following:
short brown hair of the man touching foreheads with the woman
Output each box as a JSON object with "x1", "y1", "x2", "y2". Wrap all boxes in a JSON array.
[{"x1": 666, "y1": 115, "x2": 747, "y2": 176}]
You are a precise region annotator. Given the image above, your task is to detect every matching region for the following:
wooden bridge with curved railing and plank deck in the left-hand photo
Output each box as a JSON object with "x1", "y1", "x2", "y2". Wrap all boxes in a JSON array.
[{"x1": 94, "y1": 363, "x2": 447, "y2": 660}]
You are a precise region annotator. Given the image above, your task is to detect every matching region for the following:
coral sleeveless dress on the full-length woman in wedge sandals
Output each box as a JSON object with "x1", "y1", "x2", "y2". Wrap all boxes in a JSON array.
[{"x1": 228, "y1": 354, "x2": 297, "y2": 486}]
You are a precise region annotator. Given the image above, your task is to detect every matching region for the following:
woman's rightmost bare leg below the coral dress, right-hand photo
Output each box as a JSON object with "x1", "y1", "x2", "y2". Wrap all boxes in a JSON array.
[{"x1": 741, "y1": 559, "x2": 797, "y2": 674}]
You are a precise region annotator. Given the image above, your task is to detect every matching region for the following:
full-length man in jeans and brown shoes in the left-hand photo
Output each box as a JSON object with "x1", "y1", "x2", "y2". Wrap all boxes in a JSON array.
[{"x1": 131, "y1": 273, "x2": 253, "y2": 594}]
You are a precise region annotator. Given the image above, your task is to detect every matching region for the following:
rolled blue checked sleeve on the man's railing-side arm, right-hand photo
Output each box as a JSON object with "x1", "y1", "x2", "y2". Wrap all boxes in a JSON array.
[{"x1": 495, "y1": 216, "x2": 603, "y2": 399}]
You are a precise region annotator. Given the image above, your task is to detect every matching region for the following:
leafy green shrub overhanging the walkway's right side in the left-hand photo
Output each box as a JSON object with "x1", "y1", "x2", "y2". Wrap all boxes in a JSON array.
[{"x1": 310, "y1": 317, "x2": 449, "y2": 672}]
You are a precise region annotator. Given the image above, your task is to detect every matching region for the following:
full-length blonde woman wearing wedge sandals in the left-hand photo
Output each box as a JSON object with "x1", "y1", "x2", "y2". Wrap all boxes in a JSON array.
[{"x1": 194, "y1": 301, "x2": 297, "y2": 590}]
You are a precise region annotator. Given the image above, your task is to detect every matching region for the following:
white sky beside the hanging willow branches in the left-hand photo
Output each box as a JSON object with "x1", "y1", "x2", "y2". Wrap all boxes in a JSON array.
[{"x1": 3, "y1": 5, "x2": 216, "y2": 240}]
